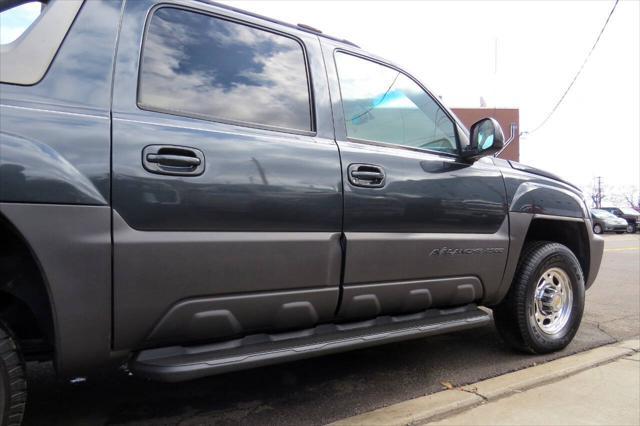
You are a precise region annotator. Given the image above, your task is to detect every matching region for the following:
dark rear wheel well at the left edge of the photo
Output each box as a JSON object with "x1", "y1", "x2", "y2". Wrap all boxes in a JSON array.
[{"x1": 0, "y1": 215, "x2": 55, "y2": 359}]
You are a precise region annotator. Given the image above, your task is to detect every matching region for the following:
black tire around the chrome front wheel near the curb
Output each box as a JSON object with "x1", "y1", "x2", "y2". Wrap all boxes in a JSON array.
[{"x1": 493, "y1": 241, "x2": 585, "y2": 354}]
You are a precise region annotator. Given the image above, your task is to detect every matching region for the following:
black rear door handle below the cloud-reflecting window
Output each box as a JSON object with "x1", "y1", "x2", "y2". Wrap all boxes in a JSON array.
[{"x1": 142, "y1": 145, "x2": 204, "y2": 176}]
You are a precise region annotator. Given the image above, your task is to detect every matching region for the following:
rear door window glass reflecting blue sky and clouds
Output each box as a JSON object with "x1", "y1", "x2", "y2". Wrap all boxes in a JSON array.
[{"x1": 138, "y1": 7, "x2": 312, "y2": 131}]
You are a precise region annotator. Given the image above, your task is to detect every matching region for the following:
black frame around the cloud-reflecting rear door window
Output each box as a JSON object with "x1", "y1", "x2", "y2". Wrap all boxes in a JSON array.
[{"x1": 135, "y1": 3, "x2": 318, "y2": 136}]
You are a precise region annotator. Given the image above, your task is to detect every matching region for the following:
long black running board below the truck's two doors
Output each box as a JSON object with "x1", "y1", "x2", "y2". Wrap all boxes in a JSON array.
[{"x1": 129, "y1": 305, "x2": 491, "y2": 382}]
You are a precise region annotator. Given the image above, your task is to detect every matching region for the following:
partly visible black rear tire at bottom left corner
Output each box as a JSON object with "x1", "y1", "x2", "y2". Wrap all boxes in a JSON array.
[{"x1": 0, "y1": 322, "x2": 27, "y2": 426}]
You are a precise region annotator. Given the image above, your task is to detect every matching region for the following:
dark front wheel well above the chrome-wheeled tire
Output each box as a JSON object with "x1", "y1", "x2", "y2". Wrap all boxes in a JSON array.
[{"x1": 525, "y1": 219, "x2": 589, "y2": 283}]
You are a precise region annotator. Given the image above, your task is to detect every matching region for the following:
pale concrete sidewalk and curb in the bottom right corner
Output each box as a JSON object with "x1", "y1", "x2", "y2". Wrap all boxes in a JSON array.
[{"x1": 335, "y1": 339, "x2": 640, "y2": 425}]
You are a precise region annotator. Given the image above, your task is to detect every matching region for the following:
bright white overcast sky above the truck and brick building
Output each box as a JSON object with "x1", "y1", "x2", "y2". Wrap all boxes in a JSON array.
[{"x1": 0, "y1": 0, "x2": 640, "y2": 196}]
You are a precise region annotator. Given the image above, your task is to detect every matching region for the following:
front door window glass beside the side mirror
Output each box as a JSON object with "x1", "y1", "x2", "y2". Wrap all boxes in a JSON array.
[{"x1": 336, "y1": 52, "x2": 457, "y2": 153}]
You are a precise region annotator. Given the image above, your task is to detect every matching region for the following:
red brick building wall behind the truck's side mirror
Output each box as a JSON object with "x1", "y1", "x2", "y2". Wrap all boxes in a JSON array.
[{"x1": 452, "y1": 108, "x2": 520, "y2": 161}]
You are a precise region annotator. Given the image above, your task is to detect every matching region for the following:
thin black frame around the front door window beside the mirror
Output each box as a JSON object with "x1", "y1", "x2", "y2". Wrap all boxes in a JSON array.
[{"x1": 332, "y1": 48, "x2": 462, "y2": 158}]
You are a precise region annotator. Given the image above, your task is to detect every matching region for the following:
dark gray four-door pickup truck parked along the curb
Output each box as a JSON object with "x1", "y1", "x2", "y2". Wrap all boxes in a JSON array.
[{"x1": 0, "y1": 0, "x2": 603, "y2": 424}]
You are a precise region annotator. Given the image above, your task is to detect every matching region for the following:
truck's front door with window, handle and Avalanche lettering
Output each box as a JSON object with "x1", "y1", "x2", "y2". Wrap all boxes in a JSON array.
[{"x1": 323, "y1": 45, "x2": 509, "y2": 318}]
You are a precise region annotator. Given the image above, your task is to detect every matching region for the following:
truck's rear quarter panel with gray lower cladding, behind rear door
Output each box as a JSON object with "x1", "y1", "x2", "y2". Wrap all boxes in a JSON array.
[{"x1": 0, "y1": 0, "x2": 122, "y2": 374}]
